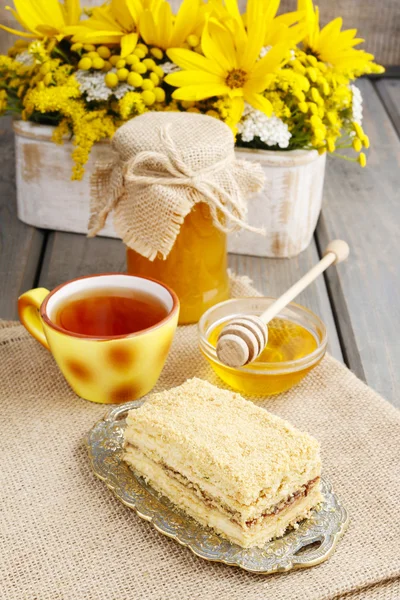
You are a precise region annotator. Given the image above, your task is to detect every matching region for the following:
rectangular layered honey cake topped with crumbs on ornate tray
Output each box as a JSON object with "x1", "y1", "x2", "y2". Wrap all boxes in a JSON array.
[{"x1": 124, "y1": 379, "x2": 322, "y2": 548}]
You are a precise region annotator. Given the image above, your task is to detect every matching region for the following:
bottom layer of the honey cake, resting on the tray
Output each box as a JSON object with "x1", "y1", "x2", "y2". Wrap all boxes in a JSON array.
[{"x1": 124, "y1": 444, "x2": 322, "y2": 548}]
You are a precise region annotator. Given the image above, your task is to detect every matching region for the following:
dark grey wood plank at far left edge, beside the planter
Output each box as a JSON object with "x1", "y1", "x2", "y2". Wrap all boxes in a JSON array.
[{"x1": 0, "y1": 118, "x2": 45, "y2": 319}]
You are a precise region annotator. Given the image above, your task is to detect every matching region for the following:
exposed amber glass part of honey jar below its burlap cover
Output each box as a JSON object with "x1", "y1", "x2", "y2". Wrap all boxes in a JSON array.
[{"x1": 127, "y1": 203, "x2": 229, "y2": 324}]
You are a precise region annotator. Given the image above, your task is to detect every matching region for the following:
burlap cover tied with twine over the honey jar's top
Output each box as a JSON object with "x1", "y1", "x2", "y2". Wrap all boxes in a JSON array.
[{"x1": 89, "y1": 112, "x2": 264, "y2": 260}]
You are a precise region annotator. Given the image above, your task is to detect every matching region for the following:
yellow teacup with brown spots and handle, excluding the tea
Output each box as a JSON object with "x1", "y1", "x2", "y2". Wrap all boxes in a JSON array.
[{"x1": 18, "y1": 273, "x2": 179, "y2": 404}]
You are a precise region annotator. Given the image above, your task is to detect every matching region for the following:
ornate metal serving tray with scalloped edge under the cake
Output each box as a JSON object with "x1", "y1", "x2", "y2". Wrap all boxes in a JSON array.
[{"x1": 86, "y1": 400, "x2": 348, "y2": 574}]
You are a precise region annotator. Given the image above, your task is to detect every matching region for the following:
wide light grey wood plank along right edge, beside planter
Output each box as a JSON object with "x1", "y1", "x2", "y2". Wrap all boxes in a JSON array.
[{"x1": 317, "y1": 80, "x2": 400, "y2": 405}]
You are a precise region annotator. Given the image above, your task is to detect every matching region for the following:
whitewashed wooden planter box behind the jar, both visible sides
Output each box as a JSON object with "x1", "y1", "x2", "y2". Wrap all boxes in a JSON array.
[{"x1": 14, "y1": 121, "x2": 325, "y2": 257}]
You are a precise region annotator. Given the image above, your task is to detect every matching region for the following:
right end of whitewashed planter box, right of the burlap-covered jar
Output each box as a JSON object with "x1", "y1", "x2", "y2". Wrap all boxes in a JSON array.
[{"x1": 228, "y1": 148, "x2": 326, "y2": 258}]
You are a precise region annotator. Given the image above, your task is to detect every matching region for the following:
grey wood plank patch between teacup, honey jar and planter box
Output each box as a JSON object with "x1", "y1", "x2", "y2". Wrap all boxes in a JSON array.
[{"x1": 39, "y1": 231, "x2": 126, "y2": 289}]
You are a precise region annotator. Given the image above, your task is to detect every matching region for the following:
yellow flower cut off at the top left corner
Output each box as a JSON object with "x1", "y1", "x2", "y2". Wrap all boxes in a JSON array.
[{"x1": 0, "y1": 0, "x2": 81, "y2": 39}]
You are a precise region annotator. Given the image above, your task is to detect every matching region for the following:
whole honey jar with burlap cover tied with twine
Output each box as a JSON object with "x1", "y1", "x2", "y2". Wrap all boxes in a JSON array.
[{"x1": 89, "y1": 111, "x2": 265, "y2": 324}]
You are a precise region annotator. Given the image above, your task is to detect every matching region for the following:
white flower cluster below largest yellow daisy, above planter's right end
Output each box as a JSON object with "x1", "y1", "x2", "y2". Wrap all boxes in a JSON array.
[{"x1": 238, "y1": 104, "x2": 292, "y2": 148}]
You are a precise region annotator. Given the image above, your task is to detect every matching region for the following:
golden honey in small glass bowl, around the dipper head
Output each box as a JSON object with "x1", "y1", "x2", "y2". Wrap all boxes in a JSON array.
[{"x1": 207, "y1": 318, "x2": 323, "y2": 395}]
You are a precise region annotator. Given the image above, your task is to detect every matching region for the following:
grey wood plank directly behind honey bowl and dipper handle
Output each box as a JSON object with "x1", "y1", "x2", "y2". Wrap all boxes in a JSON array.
[{"x1": 229, "y1": 242, "x2": 343, "y2": 360}]
